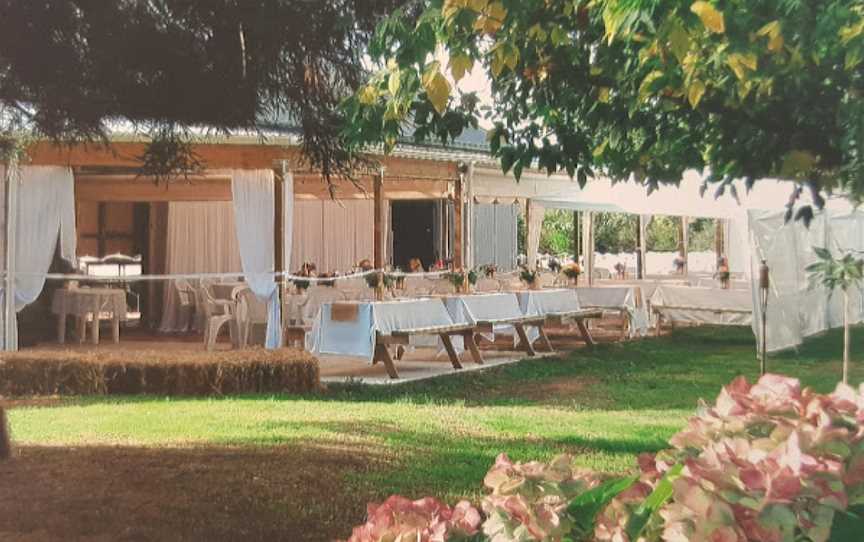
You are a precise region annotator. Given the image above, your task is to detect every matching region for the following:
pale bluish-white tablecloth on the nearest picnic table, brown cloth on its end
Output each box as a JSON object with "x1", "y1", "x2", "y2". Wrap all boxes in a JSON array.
[{"x1": 306, "y1": 299, "x2": 453, "y2": 363}]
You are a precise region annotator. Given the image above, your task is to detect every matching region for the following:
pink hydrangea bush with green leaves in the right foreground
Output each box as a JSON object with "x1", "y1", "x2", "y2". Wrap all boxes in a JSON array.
[{"x1": 351, "y1": 375, "x2": 864, "y2": 542}]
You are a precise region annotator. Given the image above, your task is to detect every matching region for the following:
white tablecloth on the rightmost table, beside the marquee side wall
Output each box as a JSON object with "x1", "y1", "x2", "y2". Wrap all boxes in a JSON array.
[{"x1": 651, "y1": 286, "x2": 753, "y2": 326}]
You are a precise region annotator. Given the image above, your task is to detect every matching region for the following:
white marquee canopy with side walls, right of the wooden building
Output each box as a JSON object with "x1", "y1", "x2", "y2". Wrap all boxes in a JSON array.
[{"x1": 472, "y1": 170, "x2": 864, "y2": 351}]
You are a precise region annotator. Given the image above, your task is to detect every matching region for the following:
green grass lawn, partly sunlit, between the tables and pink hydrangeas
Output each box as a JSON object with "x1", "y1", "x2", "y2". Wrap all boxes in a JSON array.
[{"x1": 0, "y1": 328, "x2": 864, "y2": 540}]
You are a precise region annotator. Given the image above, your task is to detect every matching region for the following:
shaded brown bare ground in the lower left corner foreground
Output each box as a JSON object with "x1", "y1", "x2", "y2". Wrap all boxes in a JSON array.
[{"x1": 0, "y1": 447, "x2": 384, "y2": 542}]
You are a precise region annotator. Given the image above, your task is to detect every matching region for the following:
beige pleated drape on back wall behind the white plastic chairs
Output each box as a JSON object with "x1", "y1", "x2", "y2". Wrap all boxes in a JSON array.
[{"x1": 159, "y1": 201, "x2": 243, "y2": 333}]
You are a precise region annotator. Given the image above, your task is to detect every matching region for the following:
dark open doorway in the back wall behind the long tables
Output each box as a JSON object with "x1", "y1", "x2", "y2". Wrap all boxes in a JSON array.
[{"x1": 390, "y1": 201, "x2": 436, "y2": 270}]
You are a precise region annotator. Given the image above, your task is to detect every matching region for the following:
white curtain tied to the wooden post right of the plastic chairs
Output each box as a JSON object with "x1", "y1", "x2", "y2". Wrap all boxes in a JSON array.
[{"x1": 231, "y1": 169, "x2": 282, "y2": 349}]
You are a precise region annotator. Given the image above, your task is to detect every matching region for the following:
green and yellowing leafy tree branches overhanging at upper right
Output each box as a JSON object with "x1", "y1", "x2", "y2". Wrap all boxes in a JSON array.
[{"x1": 345, "y1": 0, "x2": 864, "y2": 219}]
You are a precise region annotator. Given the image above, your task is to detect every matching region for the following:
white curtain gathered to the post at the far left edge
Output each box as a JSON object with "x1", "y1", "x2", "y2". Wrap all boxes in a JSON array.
[{"x1": 0, "y1": 166, "x2": 77, "y2": 350}]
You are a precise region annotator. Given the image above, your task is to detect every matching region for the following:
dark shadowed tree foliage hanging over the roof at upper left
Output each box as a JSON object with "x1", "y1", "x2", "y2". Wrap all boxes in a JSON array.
[{"x1": 0, "y1": 0, "x2": 405, "y2": 177}]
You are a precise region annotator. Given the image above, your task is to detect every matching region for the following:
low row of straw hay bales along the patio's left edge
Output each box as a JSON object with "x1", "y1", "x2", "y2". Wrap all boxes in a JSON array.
[{"x1": 0, "y1": 348, "x2": 320, "y2": 396}]
